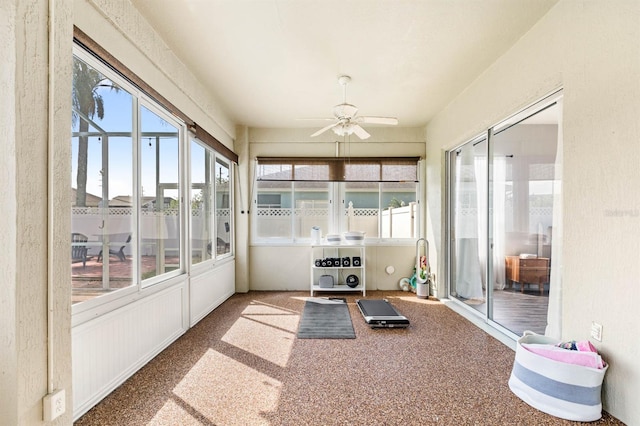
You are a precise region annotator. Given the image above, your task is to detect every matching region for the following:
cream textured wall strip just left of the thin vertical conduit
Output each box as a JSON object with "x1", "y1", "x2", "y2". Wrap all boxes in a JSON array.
[{"x1": 15, "y1": 1, "x2": 48, "y2": 423}]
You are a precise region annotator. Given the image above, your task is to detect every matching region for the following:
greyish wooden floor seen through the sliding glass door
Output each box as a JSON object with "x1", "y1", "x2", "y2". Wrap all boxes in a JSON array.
[{"x1": 458, "y1": 284, "x2": 549, "y2": 336}]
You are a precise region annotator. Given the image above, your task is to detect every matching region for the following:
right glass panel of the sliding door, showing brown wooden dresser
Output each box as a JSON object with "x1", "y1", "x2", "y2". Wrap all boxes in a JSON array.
[{"x1": 490, "y1": 104, "x2": 558, "y2": 335}]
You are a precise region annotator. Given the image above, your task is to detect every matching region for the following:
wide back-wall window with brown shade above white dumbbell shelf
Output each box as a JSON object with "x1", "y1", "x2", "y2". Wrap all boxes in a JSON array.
[{"x1": 254, "y1": 158, "x2": 419, "y2": 242}]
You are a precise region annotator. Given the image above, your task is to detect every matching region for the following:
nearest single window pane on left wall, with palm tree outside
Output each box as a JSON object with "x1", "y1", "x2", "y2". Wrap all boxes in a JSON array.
[{"x1": 70, "y1": 55, "x2": 138, "y2": 303}]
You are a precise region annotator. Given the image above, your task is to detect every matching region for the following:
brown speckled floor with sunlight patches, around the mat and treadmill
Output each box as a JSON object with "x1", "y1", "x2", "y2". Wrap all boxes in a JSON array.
[{"x1": 76, "y1": 291, "x2": 622, "y2": 426}]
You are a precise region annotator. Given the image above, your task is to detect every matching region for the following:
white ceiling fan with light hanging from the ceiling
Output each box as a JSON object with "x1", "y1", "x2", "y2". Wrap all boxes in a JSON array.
[{"x1": 304, "y1": 75, "x2": 398, "y2": 139}]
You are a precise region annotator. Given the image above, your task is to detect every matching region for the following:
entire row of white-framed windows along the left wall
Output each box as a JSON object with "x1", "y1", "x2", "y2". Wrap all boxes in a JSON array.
[{"x1": 70, "y1": 41, "x2": 237, "y2": 306}]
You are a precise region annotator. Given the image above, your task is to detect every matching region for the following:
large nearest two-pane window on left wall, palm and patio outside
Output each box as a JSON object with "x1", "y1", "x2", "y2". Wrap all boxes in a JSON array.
[{"x1": 71, "y1": 48, "x2": 184, "y2": 302}]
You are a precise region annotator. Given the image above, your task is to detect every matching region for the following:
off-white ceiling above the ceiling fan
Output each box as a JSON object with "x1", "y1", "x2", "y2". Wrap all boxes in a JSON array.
[{"x1": 131, "y1": 0, "x2": 557, "y2": 128}]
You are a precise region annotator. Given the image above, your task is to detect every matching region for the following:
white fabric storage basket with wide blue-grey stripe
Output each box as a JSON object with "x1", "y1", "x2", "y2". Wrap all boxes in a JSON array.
[{"x1": 509, "y1": 331, "x2": 608, "y2": 422}]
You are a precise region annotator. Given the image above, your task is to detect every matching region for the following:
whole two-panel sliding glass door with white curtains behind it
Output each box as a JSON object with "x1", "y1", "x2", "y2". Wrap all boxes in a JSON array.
[{"x1": 447, "y1": 91, "x2": 562, "y2": 335}]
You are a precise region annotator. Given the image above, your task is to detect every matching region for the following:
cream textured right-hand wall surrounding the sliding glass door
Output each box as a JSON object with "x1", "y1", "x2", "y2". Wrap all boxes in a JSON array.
[{"x1": 427, "y1": 0, "x2": 640, "y2": 424}]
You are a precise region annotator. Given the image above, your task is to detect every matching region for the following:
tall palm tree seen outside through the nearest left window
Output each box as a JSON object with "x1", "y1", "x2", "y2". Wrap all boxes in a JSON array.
[{"x1": 72, "y1": 57, "x2": 120, "y2": 207}]
